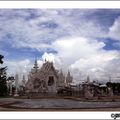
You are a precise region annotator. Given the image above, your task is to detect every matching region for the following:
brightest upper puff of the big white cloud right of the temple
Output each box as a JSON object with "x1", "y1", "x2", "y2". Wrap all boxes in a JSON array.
[{"x1": 53, "y1": 37, "x2": 104, "y2": 65}]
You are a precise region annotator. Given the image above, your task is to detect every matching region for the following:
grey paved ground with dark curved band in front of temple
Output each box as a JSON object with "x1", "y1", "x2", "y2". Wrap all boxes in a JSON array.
[{"x1": 0, "y1": 98, "x2": 120, "y2": 111}]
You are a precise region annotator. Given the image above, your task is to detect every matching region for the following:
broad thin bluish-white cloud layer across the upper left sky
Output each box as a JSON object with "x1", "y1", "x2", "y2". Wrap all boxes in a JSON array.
[{"x1": 0, "y1": 9, "x2": 105, "y2": 51}]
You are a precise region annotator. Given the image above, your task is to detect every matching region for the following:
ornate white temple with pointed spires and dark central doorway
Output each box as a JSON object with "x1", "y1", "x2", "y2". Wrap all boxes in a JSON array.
[{"x1": 26, "y1": 60, "x2": 72, "y2": 93}]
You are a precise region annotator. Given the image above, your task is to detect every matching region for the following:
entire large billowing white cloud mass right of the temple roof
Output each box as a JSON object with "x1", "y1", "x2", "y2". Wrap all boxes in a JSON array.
[{"x1": 50, "y1": 37, "x2": 119, "y2": 82}]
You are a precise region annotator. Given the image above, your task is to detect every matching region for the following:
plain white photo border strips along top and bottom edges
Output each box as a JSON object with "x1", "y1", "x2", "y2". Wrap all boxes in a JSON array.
[{"x1": 0, "y1": 1, "x2": 120, "y2": 120}]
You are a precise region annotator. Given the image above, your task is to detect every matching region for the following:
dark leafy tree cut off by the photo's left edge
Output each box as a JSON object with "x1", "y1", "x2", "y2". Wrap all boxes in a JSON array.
[{"x1": 0, "y1": 55, "x2": 7, "y2": 96}]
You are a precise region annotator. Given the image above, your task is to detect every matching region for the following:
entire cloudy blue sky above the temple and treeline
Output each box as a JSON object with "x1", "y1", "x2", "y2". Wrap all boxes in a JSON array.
[{"x1": 0, "y1": 9, "x2": 120, "y2": 81}]
